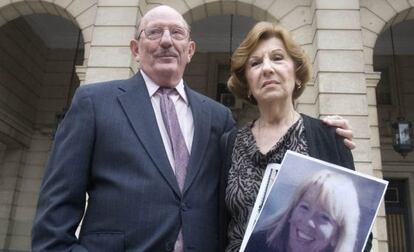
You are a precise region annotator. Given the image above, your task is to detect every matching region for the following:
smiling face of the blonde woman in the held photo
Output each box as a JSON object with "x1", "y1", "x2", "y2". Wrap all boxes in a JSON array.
[{"x1": 288, "y1": 188, "x2": 338, "y2": 252}]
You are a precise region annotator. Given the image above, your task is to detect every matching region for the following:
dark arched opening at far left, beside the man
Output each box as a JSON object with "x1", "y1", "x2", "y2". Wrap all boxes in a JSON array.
[{"x1": 0, "y1": 1, "x2": 90, "y2": 251}]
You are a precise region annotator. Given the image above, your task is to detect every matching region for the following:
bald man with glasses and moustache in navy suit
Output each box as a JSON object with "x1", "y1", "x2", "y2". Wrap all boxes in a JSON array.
[{"x1": 32, "y1": 6, "x2": 356, "y2": 252}]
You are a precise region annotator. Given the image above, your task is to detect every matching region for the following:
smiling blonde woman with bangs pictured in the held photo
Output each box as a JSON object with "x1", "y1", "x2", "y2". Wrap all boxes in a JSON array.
[{"x1": 246, "y1": 170, "x2": 360, "y2": 252}]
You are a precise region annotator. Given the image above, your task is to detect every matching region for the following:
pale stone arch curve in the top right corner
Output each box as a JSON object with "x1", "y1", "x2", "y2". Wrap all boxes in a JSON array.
[{"x1": 360, "y1": 0, "x2": 414, "y2": 72}]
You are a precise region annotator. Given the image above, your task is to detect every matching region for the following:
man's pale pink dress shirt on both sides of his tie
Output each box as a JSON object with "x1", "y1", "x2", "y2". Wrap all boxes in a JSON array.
[{"x1": 140, "y1": 70, "x2": 194, "y2": 171}]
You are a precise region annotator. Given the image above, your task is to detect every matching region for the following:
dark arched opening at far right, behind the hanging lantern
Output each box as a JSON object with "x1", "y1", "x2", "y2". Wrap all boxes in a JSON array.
[{"x1": 373, "y1": 17, "x2": 414, "y2": 251}]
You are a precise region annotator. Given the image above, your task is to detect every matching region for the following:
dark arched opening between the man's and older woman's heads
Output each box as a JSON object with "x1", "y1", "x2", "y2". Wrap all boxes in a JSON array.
[{"x1": 184, "y1": 14, "x2": 257, "y2": 123}]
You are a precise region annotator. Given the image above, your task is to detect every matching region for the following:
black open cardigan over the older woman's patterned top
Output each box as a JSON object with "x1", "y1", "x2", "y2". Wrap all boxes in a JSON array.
[{"x1": 219, "y1": 114, "x2": 372, "y2": 252}]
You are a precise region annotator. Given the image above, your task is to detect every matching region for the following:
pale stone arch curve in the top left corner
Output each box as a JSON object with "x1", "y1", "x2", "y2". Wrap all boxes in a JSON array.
[{"x1": 0, "y1": 0, "x2": 98, "y2": 64}]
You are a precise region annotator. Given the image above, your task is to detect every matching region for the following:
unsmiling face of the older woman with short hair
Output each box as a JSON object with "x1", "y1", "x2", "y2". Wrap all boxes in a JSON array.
[{"x1": 246, "y1": 37, "x2": 295, "y2": 104}]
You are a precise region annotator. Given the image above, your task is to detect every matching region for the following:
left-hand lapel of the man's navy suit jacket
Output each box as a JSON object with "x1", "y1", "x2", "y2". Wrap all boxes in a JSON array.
[{"x1": 118, "y1": 73, "x2": 180, "y2": 195}]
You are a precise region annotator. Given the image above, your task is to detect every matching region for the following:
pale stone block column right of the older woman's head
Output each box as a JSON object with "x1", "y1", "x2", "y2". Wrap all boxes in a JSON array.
[{"x1": 313, "y1": 0, "x2": 387, "y2": 251}]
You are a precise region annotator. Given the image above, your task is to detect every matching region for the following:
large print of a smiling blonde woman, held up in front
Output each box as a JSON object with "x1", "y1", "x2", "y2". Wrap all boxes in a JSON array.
[{"x1": 240, "y1": 151, "x2": 388, "y2": 252}]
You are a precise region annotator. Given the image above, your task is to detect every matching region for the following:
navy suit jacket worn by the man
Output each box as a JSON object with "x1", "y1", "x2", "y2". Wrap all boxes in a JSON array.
[{"x1": 32, "y1": 74, "x2": 234, "y2": 252}]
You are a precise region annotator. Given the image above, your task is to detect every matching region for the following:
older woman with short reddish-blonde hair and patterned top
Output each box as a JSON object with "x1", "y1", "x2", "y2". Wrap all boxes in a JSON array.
[{"x1": 221, "y1": 22, "x2": 370, "y2": 251}]
